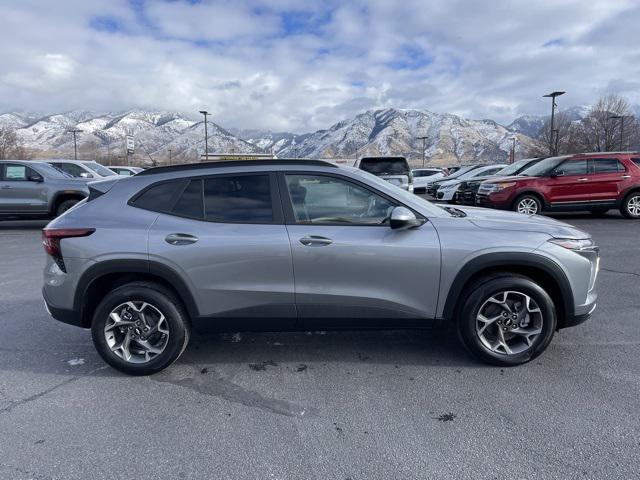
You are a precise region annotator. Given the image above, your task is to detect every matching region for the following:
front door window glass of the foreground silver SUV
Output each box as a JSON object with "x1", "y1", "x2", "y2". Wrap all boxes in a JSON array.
[{"x1": 285, "y1": 174, "x2": 395, "y2": 225}]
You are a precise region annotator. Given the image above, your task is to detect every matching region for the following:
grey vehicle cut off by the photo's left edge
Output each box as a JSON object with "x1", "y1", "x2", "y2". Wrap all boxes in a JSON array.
[{"x1": 0, "y1": 160, "x2": 89, "y2": 219}]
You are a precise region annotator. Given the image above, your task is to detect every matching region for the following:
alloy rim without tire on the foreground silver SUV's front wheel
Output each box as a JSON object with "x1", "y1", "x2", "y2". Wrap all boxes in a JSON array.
[{"x1": 476, "y1": 290, "x2": 544, "y2": 355}]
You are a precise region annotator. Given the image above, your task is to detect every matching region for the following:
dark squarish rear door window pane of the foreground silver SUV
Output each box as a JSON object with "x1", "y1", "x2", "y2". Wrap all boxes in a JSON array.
[{"x1": 204, "y1": 175, "x2": 273, "y2": 223}]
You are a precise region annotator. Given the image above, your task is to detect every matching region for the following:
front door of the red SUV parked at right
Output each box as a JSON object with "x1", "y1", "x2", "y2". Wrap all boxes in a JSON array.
[{"x1": 548, "y1": 158, "x2": 590, "y2": 206}]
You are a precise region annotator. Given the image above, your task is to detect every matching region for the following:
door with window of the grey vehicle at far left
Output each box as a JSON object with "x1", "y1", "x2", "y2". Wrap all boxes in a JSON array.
[{"x1": 0, "y1": 163, "x2": 48, "y2": 214}]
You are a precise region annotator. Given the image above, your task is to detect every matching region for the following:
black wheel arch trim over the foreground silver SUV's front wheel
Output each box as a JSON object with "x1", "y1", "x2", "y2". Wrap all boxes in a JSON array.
[{"x1": 443, "y1": 252, "x2": 575, "y2": 325}]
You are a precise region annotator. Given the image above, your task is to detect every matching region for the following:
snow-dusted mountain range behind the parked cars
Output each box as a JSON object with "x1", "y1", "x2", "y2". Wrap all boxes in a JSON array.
[{"x1": 5, "y1": 108, "x2": 548, "y2": 164}]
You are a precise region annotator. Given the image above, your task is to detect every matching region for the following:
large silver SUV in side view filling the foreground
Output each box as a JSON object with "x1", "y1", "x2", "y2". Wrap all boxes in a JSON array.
[{"x1": 43, "y1": 160, "x2": 598, "y2": 375}]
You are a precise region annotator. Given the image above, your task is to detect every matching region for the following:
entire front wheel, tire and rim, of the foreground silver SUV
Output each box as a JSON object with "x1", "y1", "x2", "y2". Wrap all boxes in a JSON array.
[{"x1": 458, "y1": 275, "x2": 557, "y2": 366}]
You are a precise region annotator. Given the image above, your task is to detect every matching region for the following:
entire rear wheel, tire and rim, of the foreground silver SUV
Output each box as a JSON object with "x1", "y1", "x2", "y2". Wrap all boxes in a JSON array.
[{"x1": 91, "y1": 282, "x2": 190, "y2": 375}]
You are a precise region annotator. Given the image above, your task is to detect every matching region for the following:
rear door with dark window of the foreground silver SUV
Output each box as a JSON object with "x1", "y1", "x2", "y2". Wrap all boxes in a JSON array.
[{"x1": 145, "y1": 173, "x2": 296, "y2": 327}]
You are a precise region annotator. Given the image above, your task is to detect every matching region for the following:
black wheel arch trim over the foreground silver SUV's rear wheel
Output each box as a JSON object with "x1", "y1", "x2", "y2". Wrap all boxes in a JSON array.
[{"x1": 73, "y1": 259, "x2": 199, "y2": 325}]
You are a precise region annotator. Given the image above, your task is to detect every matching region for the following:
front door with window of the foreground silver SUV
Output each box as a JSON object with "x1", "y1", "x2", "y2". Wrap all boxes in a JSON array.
[{"x1": 280, "y1": 173, "x2": 440, "y2": 326}]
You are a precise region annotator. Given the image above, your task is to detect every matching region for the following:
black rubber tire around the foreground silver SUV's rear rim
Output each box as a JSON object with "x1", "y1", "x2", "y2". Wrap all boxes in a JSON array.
[{"x1": 91, "y1": 282, "x2": 191, "y2": 375}]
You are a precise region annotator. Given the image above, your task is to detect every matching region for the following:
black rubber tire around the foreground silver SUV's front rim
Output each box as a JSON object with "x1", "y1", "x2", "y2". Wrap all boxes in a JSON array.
[{"x1": 457, "y1": 274, "x2": 557, "y2": 366}]
